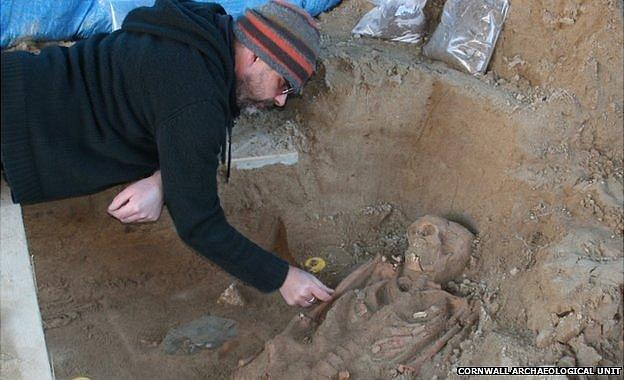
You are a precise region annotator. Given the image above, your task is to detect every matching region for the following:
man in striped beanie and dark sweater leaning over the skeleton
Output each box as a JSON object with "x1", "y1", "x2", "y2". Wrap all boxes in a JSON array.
[{"x1": 1, "y1": 0, "x2": 333, "y2": 307}]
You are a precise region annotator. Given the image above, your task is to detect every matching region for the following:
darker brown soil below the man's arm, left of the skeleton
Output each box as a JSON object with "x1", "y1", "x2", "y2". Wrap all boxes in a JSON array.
[{"x1": 25, "y1": 191, "x2": 296, "y2": 379}]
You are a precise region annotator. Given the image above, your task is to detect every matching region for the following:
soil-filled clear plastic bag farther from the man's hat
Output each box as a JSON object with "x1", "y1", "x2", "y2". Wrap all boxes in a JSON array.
[{"x1": 423, "y1": 0, "x2": 509, "y2": 74}]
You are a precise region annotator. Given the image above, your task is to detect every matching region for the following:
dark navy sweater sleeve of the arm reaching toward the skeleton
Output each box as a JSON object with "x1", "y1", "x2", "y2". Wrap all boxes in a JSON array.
[{"x1": 155, "y1": 101, "x2": 288, "y2": 292}]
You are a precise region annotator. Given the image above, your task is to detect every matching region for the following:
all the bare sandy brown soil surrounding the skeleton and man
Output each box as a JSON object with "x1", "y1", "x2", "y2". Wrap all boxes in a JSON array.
[{"x1": 15, "y1": 0, "x2": 624, "y2": 379}]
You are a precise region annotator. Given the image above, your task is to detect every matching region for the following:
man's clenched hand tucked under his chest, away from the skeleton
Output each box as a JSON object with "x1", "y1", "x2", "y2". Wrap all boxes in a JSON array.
[{"x1": 108, "y1": 170, "x2": 163, "y2": 223}]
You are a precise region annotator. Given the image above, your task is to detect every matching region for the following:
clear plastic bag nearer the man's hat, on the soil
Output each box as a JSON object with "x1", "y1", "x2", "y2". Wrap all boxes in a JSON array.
[{"x1": 352, "y1": 0, "x2": 427, "y2": 43}]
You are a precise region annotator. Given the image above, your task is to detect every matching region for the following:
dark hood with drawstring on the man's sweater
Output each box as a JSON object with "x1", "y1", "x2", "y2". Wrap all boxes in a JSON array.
[{"x1": 121, "y1": 0, "x2": 240, "y2": 177}]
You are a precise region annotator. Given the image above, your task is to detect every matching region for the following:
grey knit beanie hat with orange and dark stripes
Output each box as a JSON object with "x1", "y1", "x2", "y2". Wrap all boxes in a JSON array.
[{"x1": 234, "y1": 0, "x2": 320, "y2": 92}]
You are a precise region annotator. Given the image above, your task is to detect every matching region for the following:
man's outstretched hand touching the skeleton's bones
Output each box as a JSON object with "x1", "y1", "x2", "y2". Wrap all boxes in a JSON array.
[{"x1": 280, "y1": 265, "x2": 334, "y2": 307}]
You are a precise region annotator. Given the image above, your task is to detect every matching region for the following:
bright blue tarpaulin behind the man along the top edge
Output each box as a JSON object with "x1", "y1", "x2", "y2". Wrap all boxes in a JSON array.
[{"x1": 0, "y1": 0, "x2": 340, "y2": 48}]
